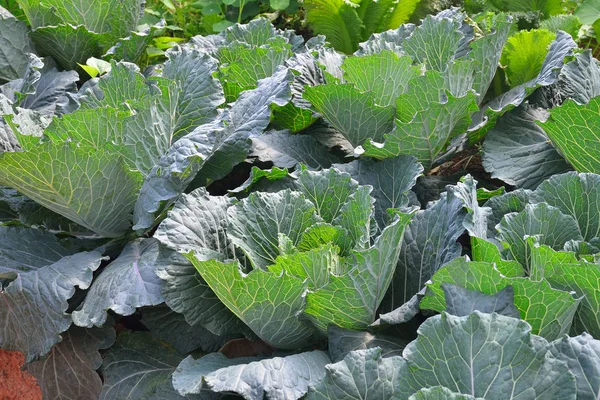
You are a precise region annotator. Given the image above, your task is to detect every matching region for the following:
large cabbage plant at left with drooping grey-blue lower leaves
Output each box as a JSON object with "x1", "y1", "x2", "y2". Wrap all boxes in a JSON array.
[{"x1": 0, "y1": 21, "x2": 304, "y2": 398}]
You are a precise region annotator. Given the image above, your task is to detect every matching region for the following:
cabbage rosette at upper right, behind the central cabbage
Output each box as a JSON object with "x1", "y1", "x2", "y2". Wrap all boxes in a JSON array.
[{"x1": 291, "y1": 9, "x2": 576, "y2": 169}]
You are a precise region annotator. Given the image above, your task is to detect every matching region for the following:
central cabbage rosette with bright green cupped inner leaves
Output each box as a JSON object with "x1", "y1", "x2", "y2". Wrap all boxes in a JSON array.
[{"x1": 156, "y1": 169, "x2": 411, "y2": 349}]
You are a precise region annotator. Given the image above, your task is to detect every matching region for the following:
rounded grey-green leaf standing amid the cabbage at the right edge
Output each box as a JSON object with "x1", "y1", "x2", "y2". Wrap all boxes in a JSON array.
[{"x1": 496, "y1": 203, "x2": 583, "y2": 270}]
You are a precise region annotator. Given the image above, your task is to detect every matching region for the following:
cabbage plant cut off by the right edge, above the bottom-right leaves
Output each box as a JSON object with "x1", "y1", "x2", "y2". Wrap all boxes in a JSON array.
[{"x1": 406, "y1": 172, "x2": 600, "y2": 340}]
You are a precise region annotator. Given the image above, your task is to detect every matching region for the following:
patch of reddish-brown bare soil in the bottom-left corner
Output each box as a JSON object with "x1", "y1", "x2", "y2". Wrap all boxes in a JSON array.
[{"x1": 0, "y1": 349, "x2": 42, "y2": 400}]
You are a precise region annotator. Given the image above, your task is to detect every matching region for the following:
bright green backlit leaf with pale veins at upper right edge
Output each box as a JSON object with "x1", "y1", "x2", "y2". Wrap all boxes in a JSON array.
[{"x1": 538, "y1": 97, "x2": 600, "y2": 174}]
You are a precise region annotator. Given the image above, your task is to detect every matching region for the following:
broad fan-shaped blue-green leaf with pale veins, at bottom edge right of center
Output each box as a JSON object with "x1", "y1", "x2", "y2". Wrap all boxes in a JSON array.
[{"x1": 399, "y1": 311, "x2": 577, "y2": 400}]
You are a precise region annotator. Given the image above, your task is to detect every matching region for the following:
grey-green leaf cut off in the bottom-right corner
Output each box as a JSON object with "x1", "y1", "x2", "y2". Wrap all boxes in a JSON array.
[{"x1": 550, "y1": 333, "x2": 600, "y2": 400}]
